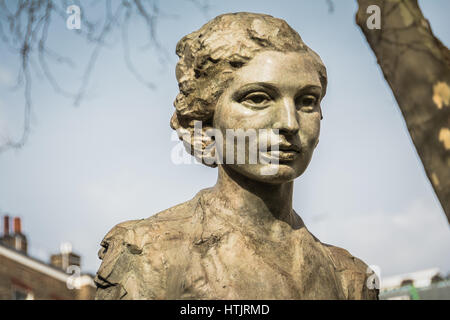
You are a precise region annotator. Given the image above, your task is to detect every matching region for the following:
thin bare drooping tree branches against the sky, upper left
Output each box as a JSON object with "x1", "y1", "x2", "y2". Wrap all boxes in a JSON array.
[{"x1": 0, "y1": 0, "x2": 208, "y2": 153}]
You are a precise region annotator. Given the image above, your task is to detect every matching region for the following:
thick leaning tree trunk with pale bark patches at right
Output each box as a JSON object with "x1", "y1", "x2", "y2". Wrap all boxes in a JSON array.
[{"x1": 356, "y1": 0, "x2": 450, "y2": 222}]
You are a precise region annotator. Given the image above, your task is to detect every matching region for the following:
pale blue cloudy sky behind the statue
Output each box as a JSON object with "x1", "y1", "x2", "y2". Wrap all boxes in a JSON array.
[{"x1": 0, "y1": 0, "x2": 450, "y2": 276}]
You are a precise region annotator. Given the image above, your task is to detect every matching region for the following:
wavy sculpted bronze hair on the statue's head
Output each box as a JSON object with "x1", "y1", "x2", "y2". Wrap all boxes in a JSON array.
[{"x1": 170, "y1": 12, "x2": 327, "y2": 167}]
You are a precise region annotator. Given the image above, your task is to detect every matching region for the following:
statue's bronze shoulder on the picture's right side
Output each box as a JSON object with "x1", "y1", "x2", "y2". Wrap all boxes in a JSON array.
[{"x1": 322, "y1": 243, "x2": 378, "y2": 300}]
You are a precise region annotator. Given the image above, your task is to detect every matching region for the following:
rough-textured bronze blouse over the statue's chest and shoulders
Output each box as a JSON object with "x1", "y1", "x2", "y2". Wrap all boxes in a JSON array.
[{"x1": 95, "y1": 189, "x2": 378, "y2": 299}]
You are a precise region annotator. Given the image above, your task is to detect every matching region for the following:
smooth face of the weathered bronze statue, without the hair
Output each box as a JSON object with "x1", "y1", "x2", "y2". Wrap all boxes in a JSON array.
[{"x1": 213, "y1": 51, "x2": 323, "y2": 183}]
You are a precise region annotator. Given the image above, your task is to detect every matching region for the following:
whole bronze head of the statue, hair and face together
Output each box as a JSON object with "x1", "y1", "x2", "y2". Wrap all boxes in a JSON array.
[{"x1": 171, "y1": 13, "x2": 327, "y2": 183}]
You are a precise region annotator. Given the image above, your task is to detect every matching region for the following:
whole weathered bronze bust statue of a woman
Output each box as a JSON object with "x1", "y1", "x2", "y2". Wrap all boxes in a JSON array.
[{"x1": 96, "y1": 13, "x2": 378, "y2": 299}]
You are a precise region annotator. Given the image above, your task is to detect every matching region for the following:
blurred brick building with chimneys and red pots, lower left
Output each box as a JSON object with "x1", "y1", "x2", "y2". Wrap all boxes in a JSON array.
[{"x1": 0, "y1": 216, "x2": 95, "y2": 300}]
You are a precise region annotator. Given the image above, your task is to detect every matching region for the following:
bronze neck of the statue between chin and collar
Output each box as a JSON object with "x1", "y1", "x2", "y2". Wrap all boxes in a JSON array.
[{"x1": 211, "y1": 165, "x2": 303, "y2": 229}]
